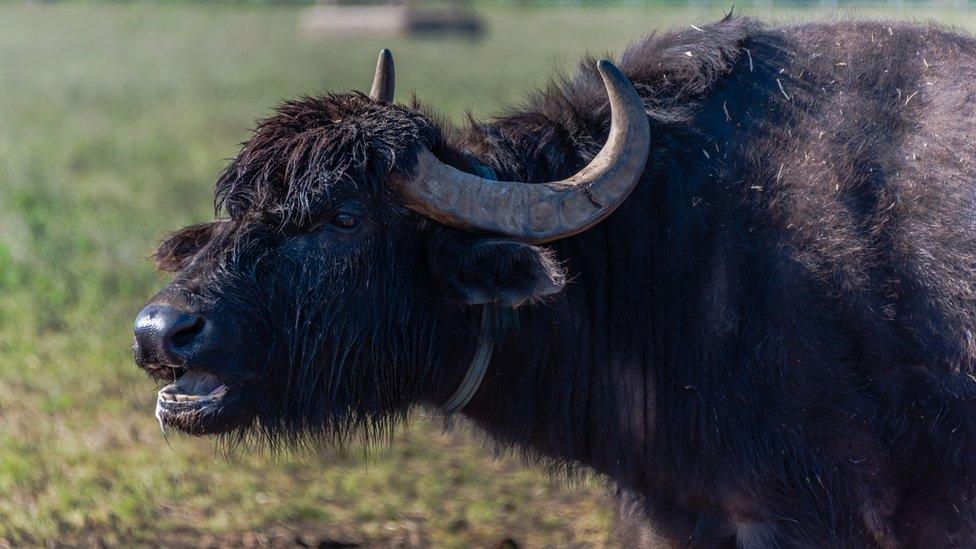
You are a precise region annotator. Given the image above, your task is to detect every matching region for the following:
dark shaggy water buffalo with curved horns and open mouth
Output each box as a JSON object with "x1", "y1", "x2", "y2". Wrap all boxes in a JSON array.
[{"x1": 134, "y1": 17, "x2": 976, "y2": 547}]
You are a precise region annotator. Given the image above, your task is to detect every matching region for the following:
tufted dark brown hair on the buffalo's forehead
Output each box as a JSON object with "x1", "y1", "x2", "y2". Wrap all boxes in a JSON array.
[{"x1": 215, "y1": 92, "x2": 440, "y2": 225}]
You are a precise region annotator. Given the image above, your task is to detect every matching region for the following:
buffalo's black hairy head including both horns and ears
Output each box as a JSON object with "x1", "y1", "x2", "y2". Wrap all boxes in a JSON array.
[{"x1": 134, "y1": 50, "x2": 649, "y2": 442}]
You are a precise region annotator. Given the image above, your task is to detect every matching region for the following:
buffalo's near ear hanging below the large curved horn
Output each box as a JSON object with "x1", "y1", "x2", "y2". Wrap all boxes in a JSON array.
[{"x1": 428, "y1": 231, "x2": 566, "y2": 307}]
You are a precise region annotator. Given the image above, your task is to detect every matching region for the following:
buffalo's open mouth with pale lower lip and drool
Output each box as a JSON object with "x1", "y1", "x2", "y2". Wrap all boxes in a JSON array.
[{"x1": 156, "y1": 368, "x2": 241, "y2": 435}]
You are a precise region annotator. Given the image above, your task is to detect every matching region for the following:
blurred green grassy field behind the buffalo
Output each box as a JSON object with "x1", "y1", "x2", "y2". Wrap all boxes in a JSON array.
[{"x1": 0, "y1": 0, "x2": 976, "y2": 547}]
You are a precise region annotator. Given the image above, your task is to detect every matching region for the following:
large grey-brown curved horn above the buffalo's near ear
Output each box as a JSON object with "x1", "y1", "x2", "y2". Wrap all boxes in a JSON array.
[{"x1": 402, "y1": 60, "x2": 651, "y2": 243}]
